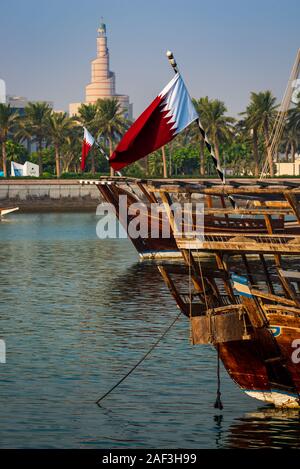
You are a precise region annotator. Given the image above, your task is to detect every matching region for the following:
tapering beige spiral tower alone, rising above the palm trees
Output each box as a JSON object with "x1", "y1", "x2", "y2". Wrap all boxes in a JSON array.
[{"x1": 85, "y1": 23, "x2": 116, "y2": 103}]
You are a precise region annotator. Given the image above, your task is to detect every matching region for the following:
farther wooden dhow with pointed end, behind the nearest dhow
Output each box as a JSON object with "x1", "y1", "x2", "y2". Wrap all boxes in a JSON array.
[{"x1": 80, "y1": 177, "x2": 299, "y2": 259}]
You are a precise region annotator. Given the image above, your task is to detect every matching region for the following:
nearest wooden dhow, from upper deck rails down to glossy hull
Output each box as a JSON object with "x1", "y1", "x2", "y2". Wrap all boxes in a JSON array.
[{"x1": 152, "y1": 183, "x2": 300, "y2": 408}]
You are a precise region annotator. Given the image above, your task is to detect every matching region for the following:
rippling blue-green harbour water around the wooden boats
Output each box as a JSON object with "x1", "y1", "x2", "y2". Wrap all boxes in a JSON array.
[{"x1": 0, "y1": 213, "x2": 300, "y2": 448}]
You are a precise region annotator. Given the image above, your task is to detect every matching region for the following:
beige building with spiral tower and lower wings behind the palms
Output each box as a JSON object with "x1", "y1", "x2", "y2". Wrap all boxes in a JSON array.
[{"x1": 69, "y1": 23, "x2": 132, "y2": 119}]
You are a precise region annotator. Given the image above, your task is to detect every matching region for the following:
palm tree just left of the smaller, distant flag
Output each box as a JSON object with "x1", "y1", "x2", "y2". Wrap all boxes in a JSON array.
[{"x1": 47, "y1": 112, "x2": 75, "y2": 178}]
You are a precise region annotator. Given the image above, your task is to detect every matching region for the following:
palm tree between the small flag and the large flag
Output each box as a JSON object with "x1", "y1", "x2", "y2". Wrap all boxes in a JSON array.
[{"x1": 96, "y1": 98, "x2": 129, "y2": 176}]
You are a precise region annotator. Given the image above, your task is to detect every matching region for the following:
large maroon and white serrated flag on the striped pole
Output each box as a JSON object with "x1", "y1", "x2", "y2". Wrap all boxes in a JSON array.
[{"x1": 110, "y1": 73, "x2": 198, "y2": 170}]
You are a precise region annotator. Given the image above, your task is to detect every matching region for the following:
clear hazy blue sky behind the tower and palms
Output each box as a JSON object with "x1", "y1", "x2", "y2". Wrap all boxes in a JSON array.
[{"x1": 0, "y1": 0, "x2": 300, "y2": 116}]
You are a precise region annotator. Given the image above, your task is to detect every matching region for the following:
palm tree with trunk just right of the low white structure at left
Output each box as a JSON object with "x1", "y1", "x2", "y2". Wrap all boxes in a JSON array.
[{"x1": 19, "y1": 102, "x2": 51, "y2": 175}]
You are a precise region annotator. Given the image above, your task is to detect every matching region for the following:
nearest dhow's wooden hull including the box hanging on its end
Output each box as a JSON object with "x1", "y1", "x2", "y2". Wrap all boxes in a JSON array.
[{"x1": 158, "y1": 260, "x2": 300, "y2": 408}]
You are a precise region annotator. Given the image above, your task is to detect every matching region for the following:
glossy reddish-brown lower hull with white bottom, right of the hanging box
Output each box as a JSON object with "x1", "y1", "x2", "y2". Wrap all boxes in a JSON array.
[{"x1": 194, "y1": 313, "x2": 300, "y2": 408}]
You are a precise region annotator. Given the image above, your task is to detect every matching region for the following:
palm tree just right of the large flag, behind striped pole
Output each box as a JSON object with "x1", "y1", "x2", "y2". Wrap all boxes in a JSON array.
[{"x1": 200, "y1": 97, "x2": 235, "y2": 168}]
